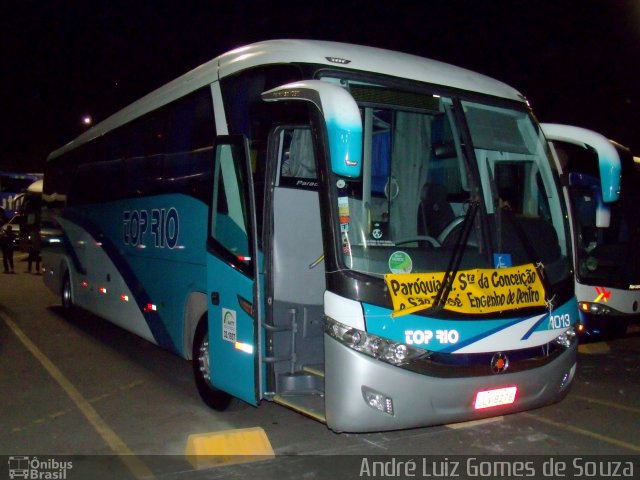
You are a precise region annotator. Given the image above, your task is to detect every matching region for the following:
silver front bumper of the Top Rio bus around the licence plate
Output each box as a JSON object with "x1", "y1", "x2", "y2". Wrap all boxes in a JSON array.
[{"x1": 324, "y1": 334, "x2": 577, "y2": 432}]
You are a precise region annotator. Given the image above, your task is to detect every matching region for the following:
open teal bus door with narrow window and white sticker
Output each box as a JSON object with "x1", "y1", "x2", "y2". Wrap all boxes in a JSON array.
[{"x1": 207, "y1": 135, "x2": 262, "y2": 405}]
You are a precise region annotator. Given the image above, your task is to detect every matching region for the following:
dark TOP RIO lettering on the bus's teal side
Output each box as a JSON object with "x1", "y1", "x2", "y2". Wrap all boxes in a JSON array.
[{"x1": 122, "y1": 207, "x2": 180, "y2": 249}]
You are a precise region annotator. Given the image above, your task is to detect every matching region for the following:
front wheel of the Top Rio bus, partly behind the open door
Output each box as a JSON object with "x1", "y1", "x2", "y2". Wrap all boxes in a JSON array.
[{"x1": 191, "y1": 314, "x2": 235, "y2": 411}]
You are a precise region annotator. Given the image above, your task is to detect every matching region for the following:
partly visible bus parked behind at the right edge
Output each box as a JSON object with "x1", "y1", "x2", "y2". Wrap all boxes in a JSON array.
[{"x1": 542, "y1": 123, "x2": 640, "y2": 339}]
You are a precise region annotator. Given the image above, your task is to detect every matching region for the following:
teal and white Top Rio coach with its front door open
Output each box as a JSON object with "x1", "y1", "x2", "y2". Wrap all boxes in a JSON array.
[{"x1": 44, "y1": 40, "x2": 578, "y2": 432}]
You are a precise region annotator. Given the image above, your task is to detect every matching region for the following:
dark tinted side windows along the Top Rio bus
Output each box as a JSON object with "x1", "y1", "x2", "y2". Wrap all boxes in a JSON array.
[{"x1": 44, "y1": 86, "x2": 215, "y2": 204}]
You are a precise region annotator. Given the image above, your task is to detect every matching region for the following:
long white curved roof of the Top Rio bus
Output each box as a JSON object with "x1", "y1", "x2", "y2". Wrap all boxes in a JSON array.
[{"x1": 47, "y1": 40, "x2": 524, "y2": 160}]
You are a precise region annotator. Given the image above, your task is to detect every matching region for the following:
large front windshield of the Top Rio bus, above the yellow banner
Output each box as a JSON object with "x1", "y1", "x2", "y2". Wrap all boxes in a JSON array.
[{"x1": 335, "y1": 80, "x2": 571, "y2": 292}]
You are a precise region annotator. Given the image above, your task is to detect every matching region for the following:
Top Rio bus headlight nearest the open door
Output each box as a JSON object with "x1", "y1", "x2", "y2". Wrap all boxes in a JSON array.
[{"x1": 325, "y1": 317, "x2": 429, "y2": 365}]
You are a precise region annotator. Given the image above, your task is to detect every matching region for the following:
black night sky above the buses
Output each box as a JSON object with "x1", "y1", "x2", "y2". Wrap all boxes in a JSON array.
[{"x1": 0, "y1": 0, "x2": 640, "y2": 171}]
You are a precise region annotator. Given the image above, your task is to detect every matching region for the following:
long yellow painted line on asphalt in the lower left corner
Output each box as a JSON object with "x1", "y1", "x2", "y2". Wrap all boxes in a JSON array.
[{"x1": 0, "y1": 311, "x2": 155, "y2": 478}]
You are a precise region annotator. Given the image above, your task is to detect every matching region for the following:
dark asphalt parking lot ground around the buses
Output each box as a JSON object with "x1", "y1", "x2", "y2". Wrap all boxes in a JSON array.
[{"x1": 0, "y1": 253, "x2": 640, "y2": 479}]
